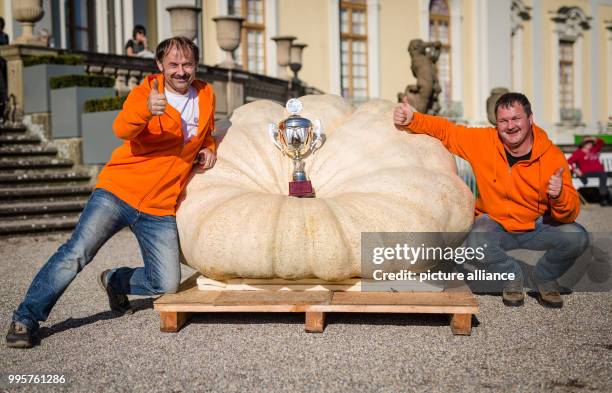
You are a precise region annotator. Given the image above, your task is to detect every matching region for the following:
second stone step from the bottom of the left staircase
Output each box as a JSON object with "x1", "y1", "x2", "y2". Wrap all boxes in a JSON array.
[{"x1": 0, "y1": 197, "x2": 88, "y2": 217}]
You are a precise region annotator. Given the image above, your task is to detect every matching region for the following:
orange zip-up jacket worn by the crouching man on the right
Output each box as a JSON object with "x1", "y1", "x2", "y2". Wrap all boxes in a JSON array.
[{"x1": 407, "y1": 112, "x2": 580, "y2": 232}]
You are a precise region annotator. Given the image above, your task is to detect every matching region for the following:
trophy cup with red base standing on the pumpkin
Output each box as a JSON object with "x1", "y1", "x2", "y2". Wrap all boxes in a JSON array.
[{"x1": 268, "y1": 98, "x2": 325, "y2": 198}]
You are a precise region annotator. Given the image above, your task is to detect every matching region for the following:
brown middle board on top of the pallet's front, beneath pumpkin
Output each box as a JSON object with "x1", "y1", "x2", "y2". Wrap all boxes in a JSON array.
[{"x1": 214, "y1": 291, "x2": 332, "y2": 306}]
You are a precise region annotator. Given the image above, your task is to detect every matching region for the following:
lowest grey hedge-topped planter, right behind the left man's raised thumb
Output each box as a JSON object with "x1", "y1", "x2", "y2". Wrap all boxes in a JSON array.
[{"x1": 82, "y1": 96, "x2": 127, "y2": 164}]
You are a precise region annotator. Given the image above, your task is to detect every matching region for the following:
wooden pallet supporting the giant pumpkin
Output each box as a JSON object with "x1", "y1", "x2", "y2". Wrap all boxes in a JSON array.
[{"x1": 154, "y1": 273, "x2": 478, "y2": 335}]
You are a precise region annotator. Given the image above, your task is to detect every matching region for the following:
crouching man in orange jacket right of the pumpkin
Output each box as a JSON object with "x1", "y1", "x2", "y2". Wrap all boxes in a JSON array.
[{"x1": 393, "y1": 93, "x2": 588, "y2": 308}]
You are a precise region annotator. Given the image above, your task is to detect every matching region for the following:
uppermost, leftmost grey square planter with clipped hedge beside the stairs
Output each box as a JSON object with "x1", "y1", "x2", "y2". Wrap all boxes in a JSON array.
[{"x1": 23, "y1": 55, "x2": 85, "y2": 113}]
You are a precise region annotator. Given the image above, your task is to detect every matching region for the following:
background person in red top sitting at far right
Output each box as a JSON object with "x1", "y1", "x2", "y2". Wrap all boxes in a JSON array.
[{"x1": 567, "y1": 136, "x2": 612, "y2": 206}]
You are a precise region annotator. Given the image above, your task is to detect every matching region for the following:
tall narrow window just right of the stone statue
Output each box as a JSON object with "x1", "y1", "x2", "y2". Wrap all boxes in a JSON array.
[{"x1": 429, "y1": 0, "x2": 452, "y2": 107}]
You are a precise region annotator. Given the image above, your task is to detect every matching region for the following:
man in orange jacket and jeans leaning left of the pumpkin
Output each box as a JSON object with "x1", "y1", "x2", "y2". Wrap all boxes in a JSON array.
[{"x1": 6, "y1": 37, "x2": 216, "y2": 348}]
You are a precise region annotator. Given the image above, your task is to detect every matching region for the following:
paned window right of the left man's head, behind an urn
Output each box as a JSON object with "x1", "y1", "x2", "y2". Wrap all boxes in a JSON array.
[{"x1": 228, "y1": 0, "x2": 266, "y2": 74}]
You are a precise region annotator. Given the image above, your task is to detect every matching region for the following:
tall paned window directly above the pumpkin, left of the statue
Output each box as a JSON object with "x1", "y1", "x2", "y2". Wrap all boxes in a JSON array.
[{"x1": 340, "y1": 0, "x2": 368, "y2": 102}]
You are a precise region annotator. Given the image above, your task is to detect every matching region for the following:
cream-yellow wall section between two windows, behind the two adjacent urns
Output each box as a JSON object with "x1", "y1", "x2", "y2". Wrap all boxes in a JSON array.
[{"x1": 280, "y1": 0, "x2": 332, "y2": 92}]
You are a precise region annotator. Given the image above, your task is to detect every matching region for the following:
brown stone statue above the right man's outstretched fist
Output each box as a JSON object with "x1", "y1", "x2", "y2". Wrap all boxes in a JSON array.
[{"x1": 397, "y1": 39, "x2": 442, "y2": 115}]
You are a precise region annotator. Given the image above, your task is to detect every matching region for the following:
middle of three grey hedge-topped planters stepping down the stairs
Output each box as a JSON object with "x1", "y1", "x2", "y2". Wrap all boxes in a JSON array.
[{"x1": 50, "y1": 75, "x2": 115, "y2": 138}]
